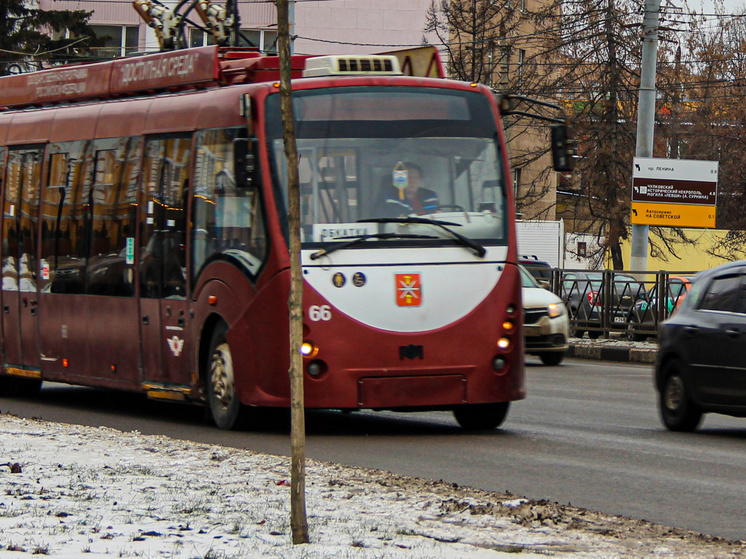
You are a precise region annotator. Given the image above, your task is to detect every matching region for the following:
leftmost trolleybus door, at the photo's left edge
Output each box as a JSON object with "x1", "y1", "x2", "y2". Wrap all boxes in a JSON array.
[{"x1": 2, "y1": 147, "x2": 42, "y2": 369}]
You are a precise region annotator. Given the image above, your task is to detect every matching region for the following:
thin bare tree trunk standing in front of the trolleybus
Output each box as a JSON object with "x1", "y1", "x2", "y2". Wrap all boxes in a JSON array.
[{"x1": 277, "y1": 0, "x2": 309, "y2": 544}]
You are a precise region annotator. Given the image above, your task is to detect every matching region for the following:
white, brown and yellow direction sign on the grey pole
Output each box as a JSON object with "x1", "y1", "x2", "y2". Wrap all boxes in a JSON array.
[{"x1": 631, "y1": 157, "x2": 718, "y2": 227}]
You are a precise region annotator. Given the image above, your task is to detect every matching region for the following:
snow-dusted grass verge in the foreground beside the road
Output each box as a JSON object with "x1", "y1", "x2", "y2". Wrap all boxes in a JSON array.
[{"x1": 0, "y1": 415, "x2": 746, "y2": 559}]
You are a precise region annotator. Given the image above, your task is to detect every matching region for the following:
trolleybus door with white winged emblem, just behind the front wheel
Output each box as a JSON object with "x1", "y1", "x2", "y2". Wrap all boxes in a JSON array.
[{"x1": 139, "y1": 137, "x2": 193, "y2": 386}]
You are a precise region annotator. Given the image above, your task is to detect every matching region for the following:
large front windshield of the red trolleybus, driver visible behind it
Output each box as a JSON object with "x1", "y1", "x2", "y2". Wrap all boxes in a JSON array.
[{"x1": 267, "y1": 87, "x2": 507, "y2": 248}]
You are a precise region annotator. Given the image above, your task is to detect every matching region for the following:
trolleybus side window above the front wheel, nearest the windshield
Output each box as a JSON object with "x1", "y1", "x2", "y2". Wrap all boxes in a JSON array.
[{"x1": 192, "y1": 128, "x2": 267, "y2": 279}]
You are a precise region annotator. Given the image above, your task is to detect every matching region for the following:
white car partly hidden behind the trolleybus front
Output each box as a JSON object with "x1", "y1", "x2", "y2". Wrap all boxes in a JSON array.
[{"x1": 518, "y1": 265, "x2": 570, "y2": 365}]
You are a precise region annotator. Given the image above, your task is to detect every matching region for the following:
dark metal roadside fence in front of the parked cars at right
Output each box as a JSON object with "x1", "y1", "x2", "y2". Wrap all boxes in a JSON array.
[{"x1": 549, "y1": 268, "x2": 697, "y2": 341}]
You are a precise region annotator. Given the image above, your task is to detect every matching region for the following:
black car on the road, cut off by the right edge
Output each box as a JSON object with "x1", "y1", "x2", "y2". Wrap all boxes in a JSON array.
[{"x1": 655, "y1": 260, "x2": 746, "y2": 431}]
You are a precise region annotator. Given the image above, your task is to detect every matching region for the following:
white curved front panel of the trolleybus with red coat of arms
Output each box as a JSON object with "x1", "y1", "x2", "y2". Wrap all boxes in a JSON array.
[{"x1": 302, "y1": 247, "x2": 507, "y2": 332}]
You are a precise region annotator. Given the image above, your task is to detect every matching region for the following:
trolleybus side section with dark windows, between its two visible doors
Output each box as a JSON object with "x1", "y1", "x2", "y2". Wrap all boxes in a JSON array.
[{"x1": 39, "y1": 137, "x2": 142, "y2": 387}]
